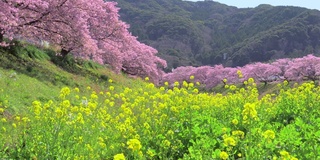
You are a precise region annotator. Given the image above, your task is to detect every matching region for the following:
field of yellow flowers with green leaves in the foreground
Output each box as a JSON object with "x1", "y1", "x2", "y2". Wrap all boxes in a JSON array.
[{"x1": 0, "y1": 80, "x2": 320, "y2": 160}]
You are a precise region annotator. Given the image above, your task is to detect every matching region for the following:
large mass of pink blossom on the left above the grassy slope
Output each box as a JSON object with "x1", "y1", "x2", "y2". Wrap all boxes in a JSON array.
[{"x1": 0, "y1": 0, "x2": 166, "y2": 82}]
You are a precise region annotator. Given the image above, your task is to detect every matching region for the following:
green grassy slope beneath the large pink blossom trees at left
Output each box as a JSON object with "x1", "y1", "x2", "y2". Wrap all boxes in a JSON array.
[{"x1": 0, "y1": 43, "x2": 144, "y2": 114}]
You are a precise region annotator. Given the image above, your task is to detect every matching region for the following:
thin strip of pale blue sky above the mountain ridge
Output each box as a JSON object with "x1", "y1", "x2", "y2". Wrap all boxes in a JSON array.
[{"x1": 188, "y1": 0, "x2": 320, "y2": 10}]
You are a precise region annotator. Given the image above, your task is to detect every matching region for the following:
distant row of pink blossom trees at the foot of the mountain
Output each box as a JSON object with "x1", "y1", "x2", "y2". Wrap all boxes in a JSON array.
[{"x1": 162, "y1": 55, "x2": 320, "y2": 89}]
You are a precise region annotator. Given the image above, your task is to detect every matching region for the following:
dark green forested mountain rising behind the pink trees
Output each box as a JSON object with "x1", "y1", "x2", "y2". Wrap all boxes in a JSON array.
[{"x1": 116, "y1": 0, "x2": 320, "y2": 70}]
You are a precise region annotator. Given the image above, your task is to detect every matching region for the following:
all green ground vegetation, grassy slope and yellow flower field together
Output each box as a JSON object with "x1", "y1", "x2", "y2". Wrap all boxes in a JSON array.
[{"x1": 0, "y1": 45, "x2": 320, "y2": 160}]
